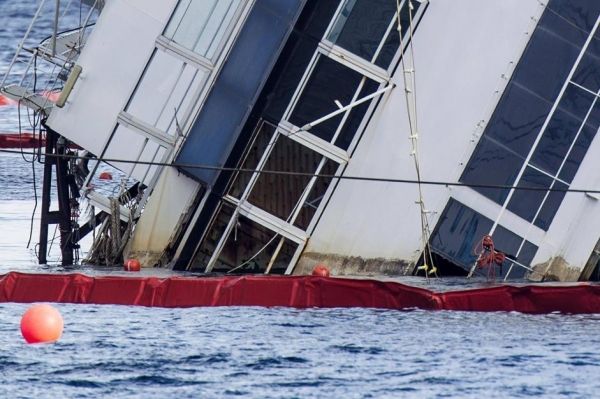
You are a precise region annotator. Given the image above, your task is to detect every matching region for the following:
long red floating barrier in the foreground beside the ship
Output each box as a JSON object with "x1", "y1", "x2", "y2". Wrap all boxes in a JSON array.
[{"x1": 0, "y1": 272, "x2": 600, "y2": 313}]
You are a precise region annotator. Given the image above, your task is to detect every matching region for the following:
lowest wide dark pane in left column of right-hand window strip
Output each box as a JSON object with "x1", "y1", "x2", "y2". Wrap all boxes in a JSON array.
[{"x1": 460, "y1": 137, "x2": 523, "y2": 204}]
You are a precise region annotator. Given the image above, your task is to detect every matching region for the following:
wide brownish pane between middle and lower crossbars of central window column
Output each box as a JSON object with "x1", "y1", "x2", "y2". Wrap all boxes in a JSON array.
[{"x1": 248, "y1": 135, "x2": 323, "y2": 220}]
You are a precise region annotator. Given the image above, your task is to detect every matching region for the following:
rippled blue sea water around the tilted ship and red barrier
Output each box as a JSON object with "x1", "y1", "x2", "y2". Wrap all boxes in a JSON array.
[{"x1": 0, "y1": 0, "x2": 600, "y2": 399}]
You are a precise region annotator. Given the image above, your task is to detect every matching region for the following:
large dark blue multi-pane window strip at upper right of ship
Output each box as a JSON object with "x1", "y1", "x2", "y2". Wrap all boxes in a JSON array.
[{"x1": 460, "y1": 0, "x2": 600, "y2": 230}]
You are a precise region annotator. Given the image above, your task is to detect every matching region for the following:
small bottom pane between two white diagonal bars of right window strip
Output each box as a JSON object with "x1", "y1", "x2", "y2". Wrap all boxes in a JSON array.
[{"x1": 508, "y1": 167, "x2": 552, "y2": 222}]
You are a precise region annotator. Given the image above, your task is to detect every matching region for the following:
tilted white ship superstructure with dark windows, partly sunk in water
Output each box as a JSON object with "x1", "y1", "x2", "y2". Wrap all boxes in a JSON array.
[{"x1": 4, "y1": 0, "x2": 600, "y2": 280}]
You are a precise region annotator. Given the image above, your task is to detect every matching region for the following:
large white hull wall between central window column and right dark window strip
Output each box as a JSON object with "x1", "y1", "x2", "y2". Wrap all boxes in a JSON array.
[{"x1": 306, "y1": 0, "x2": 543, "y2": 259}]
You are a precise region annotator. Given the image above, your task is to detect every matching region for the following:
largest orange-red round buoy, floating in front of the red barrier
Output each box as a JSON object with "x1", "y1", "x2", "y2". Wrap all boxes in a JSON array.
[{"x1": 21, "y1": 304, "x2": 63, "y2": 344}]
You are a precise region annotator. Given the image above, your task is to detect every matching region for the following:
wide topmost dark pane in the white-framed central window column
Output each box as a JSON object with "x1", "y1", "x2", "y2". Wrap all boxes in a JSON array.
[{"x1": 328, "y1": 0, "x2": 397, "y2": 61}]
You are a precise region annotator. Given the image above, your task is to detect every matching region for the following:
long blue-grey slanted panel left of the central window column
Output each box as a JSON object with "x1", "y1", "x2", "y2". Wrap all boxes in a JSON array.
[{"x1": 177, "y1": 0, "x2": 305, "y2": 185}]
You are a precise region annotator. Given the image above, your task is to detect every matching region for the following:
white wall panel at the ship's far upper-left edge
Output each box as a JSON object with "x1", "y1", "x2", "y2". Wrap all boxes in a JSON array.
[{"x1": 48, "y1": 0, "x2": 176, "y2": 155}]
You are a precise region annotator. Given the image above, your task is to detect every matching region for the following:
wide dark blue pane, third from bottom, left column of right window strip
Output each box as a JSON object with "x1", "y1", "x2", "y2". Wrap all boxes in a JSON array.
[{"x1": 513, "y1": 11, "x2": 587, "y2": 102}]
